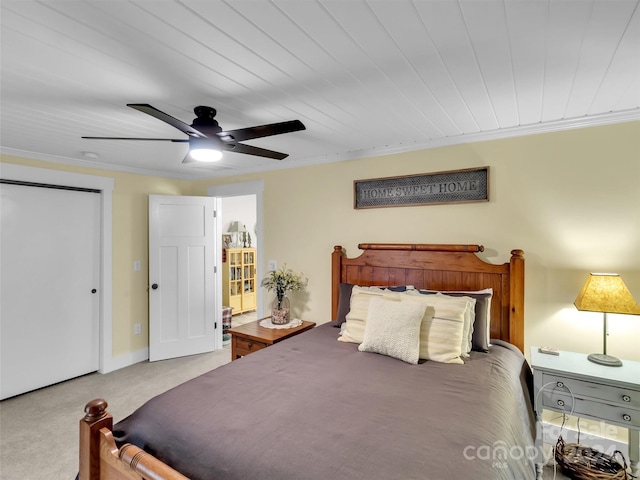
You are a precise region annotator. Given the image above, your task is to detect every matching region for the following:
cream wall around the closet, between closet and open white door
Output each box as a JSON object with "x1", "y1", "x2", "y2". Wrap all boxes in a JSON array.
[{"x1": 0, "y1": 155, "x2": 191, "y2": 357}]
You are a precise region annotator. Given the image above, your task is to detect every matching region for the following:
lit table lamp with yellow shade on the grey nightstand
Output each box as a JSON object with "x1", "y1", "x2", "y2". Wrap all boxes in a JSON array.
[{"x1": 573, "y1": 273, "x2": 640, "y2": 367}]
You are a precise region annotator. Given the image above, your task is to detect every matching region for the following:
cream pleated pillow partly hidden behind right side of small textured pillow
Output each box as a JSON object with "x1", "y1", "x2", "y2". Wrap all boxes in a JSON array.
[{"x1": 401, "y1": 295, "x2": 467, "y2": 364}]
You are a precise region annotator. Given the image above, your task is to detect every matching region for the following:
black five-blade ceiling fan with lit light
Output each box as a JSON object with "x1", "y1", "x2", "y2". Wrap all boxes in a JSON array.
[{"x1": 82, "y1": 103, "x2": 305, "y2": 163}]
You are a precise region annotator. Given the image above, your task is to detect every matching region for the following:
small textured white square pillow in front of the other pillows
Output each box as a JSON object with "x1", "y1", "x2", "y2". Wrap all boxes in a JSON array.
[{"x1": 358, "y1": 296, "x2": 427, "y2": 365}]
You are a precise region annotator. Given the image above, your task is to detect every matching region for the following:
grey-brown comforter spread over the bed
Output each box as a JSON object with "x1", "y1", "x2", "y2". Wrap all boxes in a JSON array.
[{"x1": 114, "y1": 324, "x2": 535, "y2": 480}]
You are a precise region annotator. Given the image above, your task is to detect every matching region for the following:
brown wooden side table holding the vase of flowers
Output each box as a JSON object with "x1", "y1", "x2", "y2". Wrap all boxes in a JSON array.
[{"x1": 226, "y1": 317, "x2": 316, "y2": 361}]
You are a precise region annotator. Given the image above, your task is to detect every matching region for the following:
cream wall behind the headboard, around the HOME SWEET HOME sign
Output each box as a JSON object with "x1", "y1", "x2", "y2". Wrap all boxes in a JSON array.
[{"x1": 194, "y1": 122, "x2": 640, "y2": 361}]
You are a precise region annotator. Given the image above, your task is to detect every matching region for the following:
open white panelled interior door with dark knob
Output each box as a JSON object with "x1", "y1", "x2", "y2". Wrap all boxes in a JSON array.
[{"x1": 149, "y1": 195, "x2": 221, "y2": 361}]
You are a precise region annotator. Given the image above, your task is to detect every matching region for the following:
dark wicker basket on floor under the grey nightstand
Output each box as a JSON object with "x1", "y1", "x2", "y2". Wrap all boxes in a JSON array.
[{"x1": 555, "y1": 436, "x2": 631, "y2": 480}]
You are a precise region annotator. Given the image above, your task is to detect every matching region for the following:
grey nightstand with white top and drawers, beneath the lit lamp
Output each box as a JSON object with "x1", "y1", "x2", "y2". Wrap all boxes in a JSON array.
[{"x1": 531, "y1": 347, "x2": 640, "y2": 475}]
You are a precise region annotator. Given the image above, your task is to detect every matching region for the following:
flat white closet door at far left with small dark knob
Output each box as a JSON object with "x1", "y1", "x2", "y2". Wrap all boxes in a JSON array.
[{"x1": 0, "y1": 184, "x2": 101, "y2": 398}]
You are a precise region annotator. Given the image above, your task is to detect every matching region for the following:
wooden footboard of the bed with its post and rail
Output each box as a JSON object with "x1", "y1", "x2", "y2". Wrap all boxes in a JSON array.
[{"x1": 78, "y1": 398, "x2": 189, "y2": 480}]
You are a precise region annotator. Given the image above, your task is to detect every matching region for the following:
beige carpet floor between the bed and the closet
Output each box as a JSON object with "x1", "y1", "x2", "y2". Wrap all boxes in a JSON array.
[{"x1": 0, "y1": 346, "x2": 231, "y2": 480}]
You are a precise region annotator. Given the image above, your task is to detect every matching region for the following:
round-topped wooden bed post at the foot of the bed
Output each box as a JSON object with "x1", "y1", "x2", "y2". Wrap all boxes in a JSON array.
[{"x1": 78, "y1": 398, "x2": 113, "y2": 480}]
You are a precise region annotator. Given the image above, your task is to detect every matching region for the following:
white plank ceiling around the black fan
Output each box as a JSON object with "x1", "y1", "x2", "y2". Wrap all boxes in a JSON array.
[{"x1": 0, "y1": 0, "x2": 640, "y2": 178}]
